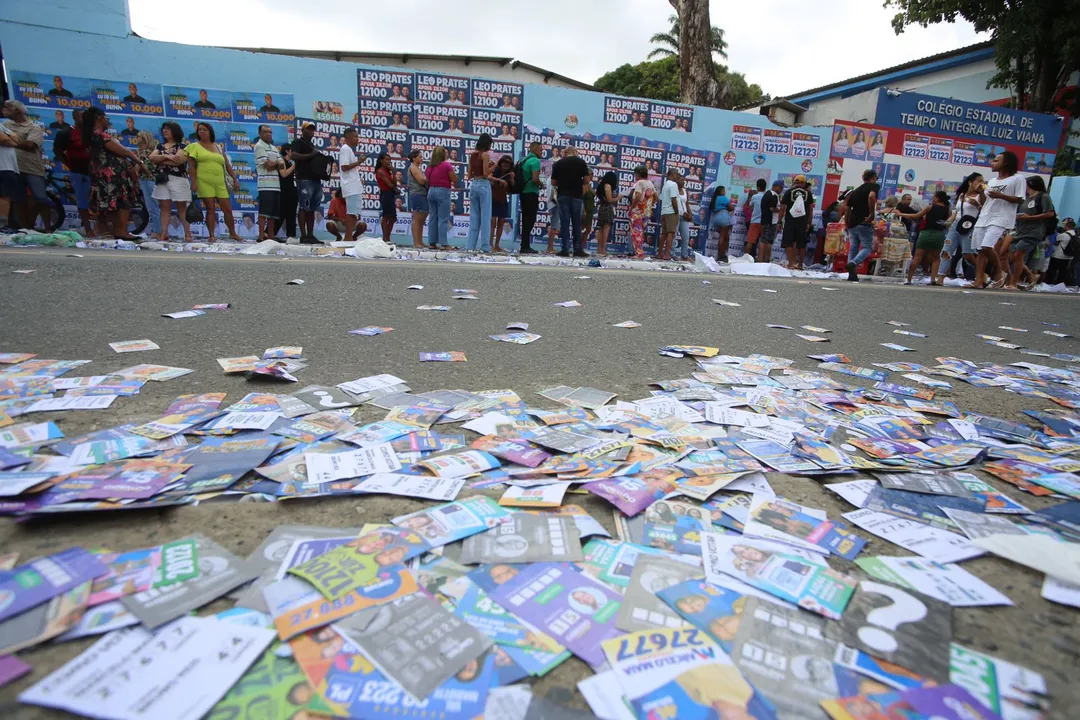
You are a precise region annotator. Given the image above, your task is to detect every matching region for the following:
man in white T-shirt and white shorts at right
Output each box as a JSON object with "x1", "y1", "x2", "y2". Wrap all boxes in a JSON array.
[{"x1": 971, "y1": 150, "x2": 1027, "y2": 289}]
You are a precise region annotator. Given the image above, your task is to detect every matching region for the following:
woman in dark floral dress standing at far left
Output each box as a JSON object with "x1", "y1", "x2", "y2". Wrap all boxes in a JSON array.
[{"x1": 81, "y1": 107, "x2": 149, "y2": 240}]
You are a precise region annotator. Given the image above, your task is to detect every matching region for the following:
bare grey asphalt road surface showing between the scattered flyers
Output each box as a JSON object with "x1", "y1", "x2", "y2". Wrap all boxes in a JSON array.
[{"x1": 0, "y1": 248, "x2": 1080, "y2": 718}]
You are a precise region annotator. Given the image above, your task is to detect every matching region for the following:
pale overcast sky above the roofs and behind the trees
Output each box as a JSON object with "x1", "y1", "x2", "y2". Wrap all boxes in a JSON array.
[{"x1": 129, "y1": 0, "x2": 986, "y2": 96}]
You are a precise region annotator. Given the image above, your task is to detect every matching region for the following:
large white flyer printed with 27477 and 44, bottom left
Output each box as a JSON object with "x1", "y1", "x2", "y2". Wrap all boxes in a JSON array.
[{"x1": 18, "y1": 617, "x2": 276, "y2": 720}]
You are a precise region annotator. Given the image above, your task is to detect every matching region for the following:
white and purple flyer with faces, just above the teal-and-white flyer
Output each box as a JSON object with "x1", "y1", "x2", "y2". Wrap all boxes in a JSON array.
[{"x1": 743, "y1": 495, "x2": 866, "y2": 560}]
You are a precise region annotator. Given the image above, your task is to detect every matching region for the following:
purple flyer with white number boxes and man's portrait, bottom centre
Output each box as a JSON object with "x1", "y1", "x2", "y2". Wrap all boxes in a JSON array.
[{"x1": 486, "y1": 562, "x2": 623, "y2": 669}]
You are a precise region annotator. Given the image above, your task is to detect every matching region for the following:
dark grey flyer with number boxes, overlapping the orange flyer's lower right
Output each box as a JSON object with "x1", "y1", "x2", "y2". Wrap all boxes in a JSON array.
[{"x1": 336, "y1": 593, "x2": 491, "y2": 702}]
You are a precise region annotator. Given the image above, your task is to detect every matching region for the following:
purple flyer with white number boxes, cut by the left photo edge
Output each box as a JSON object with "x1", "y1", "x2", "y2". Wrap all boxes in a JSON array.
[{"x1": 0, "y1": 547, "x2": 109, "y2": 621}]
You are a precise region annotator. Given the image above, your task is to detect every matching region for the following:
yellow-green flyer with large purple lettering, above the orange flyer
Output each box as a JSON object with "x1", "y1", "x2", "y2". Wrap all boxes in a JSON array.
[{"x1": 288, "y1": 527, "x2": 431, "y2": 600}]
